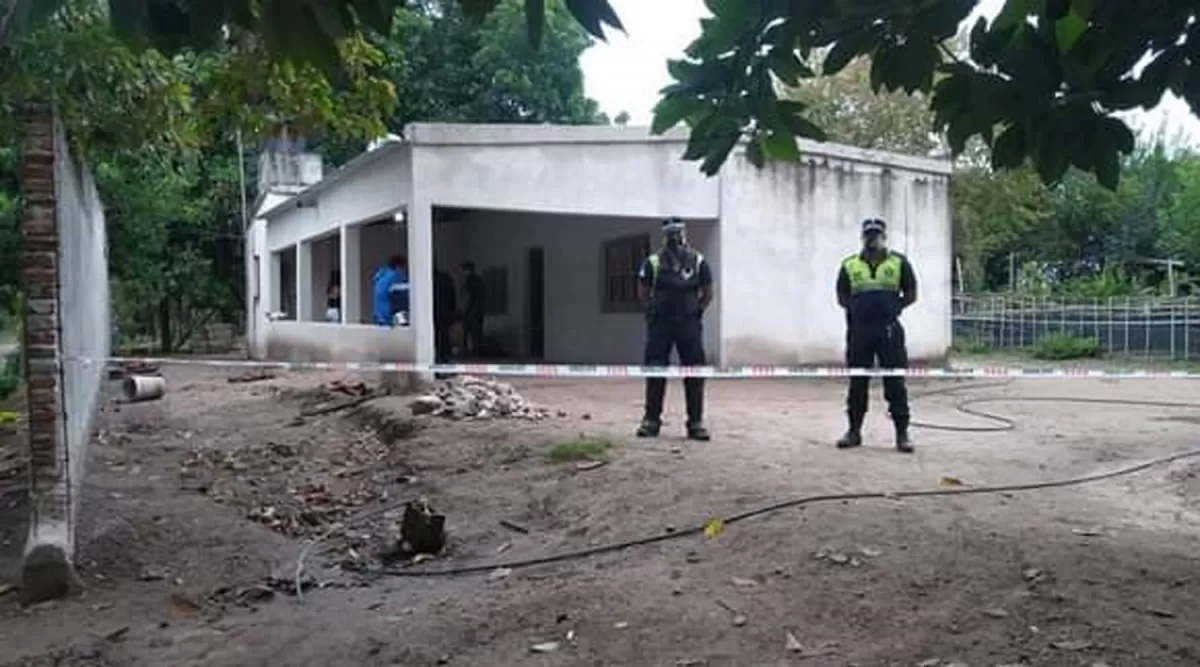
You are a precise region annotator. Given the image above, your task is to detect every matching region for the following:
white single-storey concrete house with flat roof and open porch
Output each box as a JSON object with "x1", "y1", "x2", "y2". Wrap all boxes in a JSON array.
[{"x1": 246, "y1": 125, "x2": 953, "y2": 365}]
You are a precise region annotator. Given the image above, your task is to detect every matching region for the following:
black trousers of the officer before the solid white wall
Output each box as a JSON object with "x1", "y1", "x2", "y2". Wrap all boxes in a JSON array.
[{"x1": 846, "y1": 322, "x2": 910, "y2": 427}]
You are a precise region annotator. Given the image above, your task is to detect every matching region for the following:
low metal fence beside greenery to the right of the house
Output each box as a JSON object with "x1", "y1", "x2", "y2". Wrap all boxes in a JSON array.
[{"x1": 953, "y1": 294, "x2": 1200, "y2": 360}]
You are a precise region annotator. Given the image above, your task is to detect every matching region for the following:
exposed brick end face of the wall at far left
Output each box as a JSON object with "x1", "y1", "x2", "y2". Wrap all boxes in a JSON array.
[{"x1": 20, "y1": 104, "x2": 76, "y2": 602}]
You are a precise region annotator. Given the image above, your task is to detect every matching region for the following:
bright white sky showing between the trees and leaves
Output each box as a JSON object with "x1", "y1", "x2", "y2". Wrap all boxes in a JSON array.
[{"x1": 581, "y1": 0, "x2": 1200, "y2": 145}]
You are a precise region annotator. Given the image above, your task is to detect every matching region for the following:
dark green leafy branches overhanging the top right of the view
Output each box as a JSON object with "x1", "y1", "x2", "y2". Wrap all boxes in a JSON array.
[{"x1": 654, "y1": 0, "x2": 1200, "y2": 190}]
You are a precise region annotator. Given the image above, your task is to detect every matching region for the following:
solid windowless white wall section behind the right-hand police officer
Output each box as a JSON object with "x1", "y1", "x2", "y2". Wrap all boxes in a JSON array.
[{"x1": 719, "y1": 150, "x2": 952, "y2": 365}]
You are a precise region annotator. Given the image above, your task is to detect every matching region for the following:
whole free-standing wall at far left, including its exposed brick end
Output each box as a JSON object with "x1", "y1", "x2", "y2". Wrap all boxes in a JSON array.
[{"x1": 22, "y1": 107, "x2": 112, "y2": 601}]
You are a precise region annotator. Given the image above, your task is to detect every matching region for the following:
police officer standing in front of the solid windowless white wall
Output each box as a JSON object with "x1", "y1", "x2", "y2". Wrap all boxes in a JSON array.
[{"x1": 838, "y1": 218, "x2": 917, "y2": 453}]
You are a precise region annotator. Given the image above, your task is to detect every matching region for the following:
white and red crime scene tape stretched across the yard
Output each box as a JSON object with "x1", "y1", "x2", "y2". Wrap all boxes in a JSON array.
[{"x1": 71, "y1": 356, "x2": 1200, "y2": 379}]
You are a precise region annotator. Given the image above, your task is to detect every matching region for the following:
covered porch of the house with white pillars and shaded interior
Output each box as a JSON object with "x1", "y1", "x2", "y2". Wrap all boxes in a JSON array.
[{"x1": 252, "y1": 125, "x2": 720, "y2": 363}]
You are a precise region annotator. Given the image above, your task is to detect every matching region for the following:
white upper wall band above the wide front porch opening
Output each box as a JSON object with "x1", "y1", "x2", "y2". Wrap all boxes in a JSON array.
[{"x1": 406, "y1": 125, "x2": 720, "y2": 220}]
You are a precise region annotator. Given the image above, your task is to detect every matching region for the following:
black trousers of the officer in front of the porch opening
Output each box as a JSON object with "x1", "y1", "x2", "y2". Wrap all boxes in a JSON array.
[{"x1": 643, "y1": 316, "x2": 706, "y2": 423}]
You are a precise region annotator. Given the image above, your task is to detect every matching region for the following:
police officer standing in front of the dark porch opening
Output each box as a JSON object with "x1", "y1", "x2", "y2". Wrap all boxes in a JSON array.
[{"x1": 637, "y1": 217, "x2": 713, "y2": 440}]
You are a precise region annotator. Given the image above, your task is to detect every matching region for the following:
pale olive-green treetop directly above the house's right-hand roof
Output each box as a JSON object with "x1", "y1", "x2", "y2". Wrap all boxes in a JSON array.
[{"x1": 782, "y1": 58, "x2": 941, "y2": 156}]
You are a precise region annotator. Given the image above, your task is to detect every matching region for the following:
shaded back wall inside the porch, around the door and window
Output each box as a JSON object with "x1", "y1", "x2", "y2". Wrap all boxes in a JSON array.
[{"x1": 434, "y1": 211, "x2": 721, "y2": 363}]
